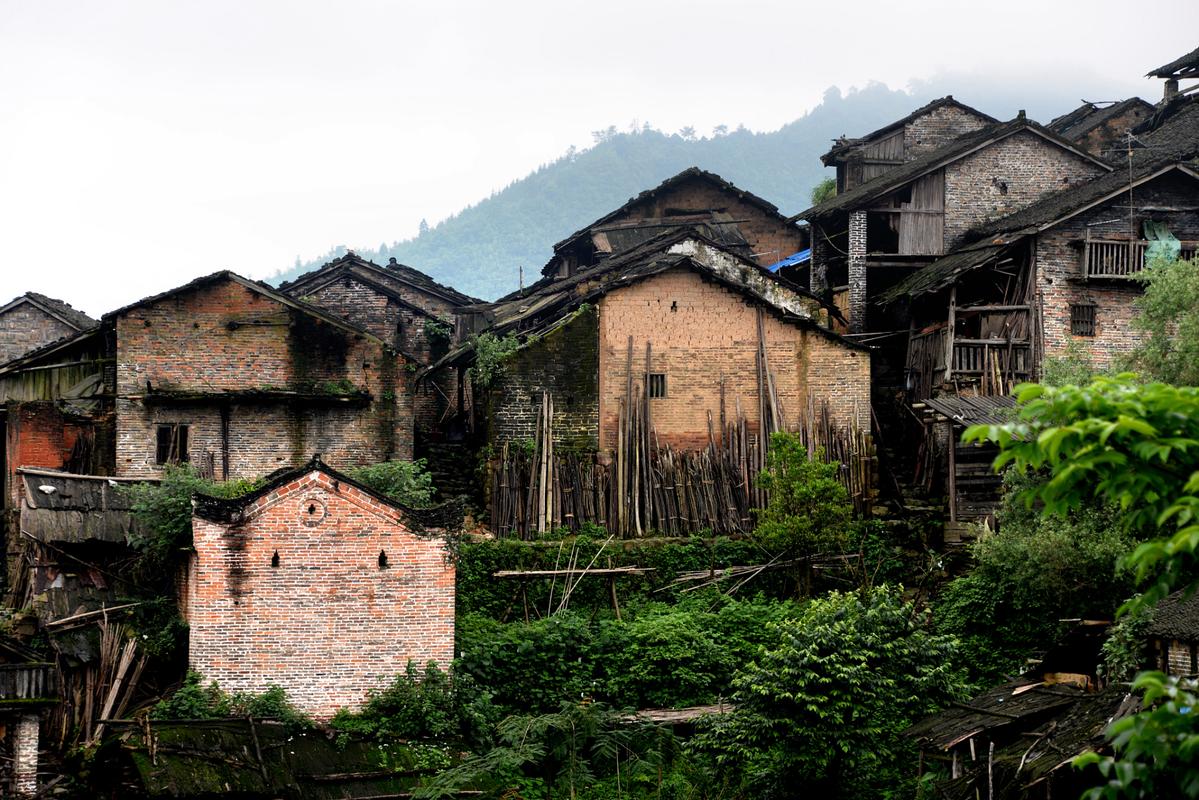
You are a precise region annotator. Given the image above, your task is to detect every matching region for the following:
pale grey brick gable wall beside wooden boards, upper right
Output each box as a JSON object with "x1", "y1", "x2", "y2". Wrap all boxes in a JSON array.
[{"x1": 945, "y1": 131, "x2": 1104, "y2": 253}]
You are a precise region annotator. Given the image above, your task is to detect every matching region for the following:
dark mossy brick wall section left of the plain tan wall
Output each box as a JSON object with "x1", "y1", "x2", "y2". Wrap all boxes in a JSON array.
[{"x1": 489, "y1": 307, "x2": 600, "y2": 450}]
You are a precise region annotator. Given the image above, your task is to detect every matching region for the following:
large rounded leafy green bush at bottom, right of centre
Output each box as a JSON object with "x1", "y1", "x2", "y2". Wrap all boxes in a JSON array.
[{"x1": 692, "y1": 587, "x2": 964, "y2": 798}]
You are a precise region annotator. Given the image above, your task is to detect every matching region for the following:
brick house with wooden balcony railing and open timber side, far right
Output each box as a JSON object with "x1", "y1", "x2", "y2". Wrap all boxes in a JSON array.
[{"x1": 880, "y1": 103, "x2": 1199, "y2": 398}]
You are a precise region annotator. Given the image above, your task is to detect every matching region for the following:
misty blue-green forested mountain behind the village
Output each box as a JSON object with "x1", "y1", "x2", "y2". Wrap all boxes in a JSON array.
[{"x1": 271, "y1": 83, "x2": 1103, "y2": 300}]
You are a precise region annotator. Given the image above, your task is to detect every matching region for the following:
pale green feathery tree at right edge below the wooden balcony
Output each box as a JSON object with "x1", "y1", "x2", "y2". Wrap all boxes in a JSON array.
[{"x1": 1129, "y1": 257, "x2": 1199, "y2": 386}]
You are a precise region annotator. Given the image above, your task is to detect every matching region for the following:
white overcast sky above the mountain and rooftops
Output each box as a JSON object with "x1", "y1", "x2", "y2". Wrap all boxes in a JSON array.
[{"x1": 0, "y1": 0, "x2": 1199, "y2": 315}]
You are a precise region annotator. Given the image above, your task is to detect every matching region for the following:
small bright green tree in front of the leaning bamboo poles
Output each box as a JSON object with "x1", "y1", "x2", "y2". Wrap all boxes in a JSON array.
[{"x1": 753, "y1": 433, "x2": 852, "y2": 595}]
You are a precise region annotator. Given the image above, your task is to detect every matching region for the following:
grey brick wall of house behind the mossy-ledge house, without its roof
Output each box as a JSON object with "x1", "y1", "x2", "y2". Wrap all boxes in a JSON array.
[{"x1": 290, "y1": 272, "x2": 458, "y2": 438}]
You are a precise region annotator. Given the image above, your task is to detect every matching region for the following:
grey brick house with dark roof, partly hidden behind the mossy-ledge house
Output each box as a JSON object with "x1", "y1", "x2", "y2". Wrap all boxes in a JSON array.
[{"x1": 279, "y1": 253, "x2": 481, "y2": 437}]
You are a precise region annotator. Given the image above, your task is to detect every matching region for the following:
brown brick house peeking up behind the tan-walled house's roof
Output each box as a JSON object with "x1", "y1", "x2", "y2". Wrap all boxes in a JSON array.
[{"x1": 541, "y1": 167, "x2": 808, "y2": 278}]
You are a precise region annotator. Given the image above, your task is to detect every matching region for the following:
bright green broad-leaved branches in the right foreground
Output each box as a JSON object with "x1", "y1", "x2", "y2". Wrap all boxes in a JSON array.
[{"x1": 965, "y1": 375, "x2": 1199, "y2": 800}]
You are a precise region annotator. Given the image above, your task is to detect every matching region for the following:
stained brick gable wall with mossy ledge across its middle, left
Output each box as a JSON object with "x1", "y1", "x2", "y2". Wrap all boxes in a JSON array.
[{"x1": 115, "y1": 281, "x2": 412, "y2": 477}]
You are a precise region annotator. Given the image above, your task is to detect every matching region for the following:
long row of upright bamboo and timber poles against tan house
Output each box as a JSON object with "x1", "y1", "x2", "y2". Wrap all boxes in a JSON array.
[{"x1": 490, "y1": 391, "x2": 878, "y2": 540}]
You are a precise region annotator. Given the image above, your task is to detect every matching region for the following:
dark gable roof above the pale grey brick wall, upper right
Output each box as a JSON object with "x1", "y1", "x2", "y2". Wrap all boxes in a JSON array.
[{"x1": 793, "y1": 116, "x2": 1111, "y2": 219}]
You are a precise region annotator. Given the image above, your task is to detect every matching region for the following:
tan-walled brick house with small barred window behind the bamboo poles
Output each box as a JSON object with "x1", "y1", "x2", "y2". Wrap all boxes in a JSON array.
[{"x1": 436, "y1": 229, "x2": 870, "y2": 451}]
